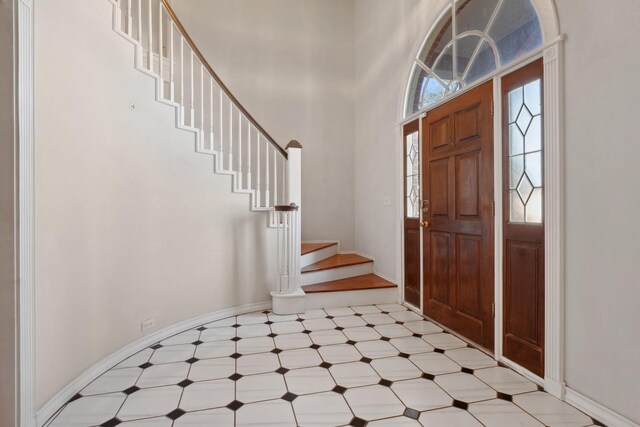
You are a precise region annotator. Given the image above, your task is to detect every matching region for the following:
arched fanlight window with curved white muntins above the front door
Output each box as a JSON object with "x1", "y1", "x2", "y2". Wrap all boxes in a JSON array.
[{"x1": 405, "y1": 0, "x2": 542, "y2": 116}]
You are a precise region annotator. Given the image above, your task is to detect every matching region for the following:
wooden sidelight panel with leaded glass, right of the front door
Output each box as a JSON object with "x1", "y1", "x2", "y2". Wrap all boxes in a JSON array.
[{"x1": 502, "y1": 59, "x2": 544, "y2": 377}]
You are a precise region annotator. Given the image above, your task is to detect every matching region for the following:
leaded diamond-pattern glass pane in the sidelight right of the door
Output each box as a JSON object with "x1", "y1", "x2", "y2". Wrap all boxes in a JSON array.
[{"x1": 508, "y1": 79, "x2": 543, "y2": 224}]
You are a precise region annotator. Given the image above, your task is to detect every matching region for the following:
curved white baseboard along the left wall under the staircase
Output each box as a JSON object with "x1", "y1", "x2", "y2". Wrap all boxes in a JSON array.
[{"x1": 37, "y1": 301, "x2": 271, "y2": 426}]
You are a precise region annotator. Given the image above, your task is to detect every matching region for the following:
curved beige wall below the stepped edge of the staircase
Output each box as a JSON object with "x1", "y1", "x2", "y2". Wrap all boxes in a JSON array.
[{"x1": 35, "y1": 0, "x2": 275, "y2": 407}]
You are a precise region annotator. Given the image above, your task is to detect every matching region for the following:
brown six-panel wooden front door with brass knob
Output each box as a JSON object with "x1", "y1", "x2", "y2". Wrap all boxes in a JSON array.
[{"x1": 421, "y1": 82, "x2": 494, "y2": 351}]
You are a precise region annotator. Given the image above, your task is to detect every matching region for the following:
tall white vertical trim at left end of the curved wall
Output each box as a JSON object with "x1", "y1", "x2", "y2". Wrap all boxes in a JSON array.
[{"x1": 16, "y1": 0, "x2": 36, "y2": 427}]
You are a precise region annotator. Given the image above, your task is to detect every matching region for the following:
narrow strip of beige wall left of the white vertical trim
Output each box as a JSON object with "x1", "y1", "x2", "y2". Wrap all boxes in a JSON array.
[{"x1": 0, "y1": 0, "x2": 17, "y2": 426}]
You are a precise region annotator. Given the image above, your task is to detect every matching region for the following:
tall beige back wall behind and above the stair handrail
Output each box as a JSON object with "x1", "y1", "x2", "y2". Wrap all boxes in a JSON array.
[{"x1": 172, "y1": 0, "x2": 358, "y2": 250}]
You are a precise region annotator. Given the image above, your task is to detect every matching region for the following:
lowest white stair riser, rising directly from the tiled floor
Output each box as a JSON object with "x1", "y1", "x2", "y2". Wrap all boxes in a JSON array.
[{"x1": 306, "y1": 287, "x2": 399, "y2": 310}]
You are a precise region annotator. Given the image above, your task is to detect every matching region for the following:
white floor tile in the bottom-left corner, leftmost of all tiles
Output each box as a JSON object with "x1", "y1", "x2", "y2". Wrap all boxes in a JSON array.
[{"x1": 50, "y1": 393, "x2": 127, "y2": 427}]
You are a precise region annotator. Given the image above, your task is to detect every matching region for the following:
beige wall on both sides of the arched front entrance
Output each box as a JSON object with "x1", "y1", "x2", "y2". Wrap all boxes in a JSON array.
[{"x1": 355, "y1": 0, "x2": 640, "y2": 422}]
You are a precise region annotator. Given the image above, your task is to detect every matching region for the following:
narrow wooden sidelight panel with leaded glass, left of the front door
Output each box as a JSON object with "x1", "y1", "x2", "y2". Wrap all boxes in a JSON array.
[{"x1": 403, "y1": 119, "x2": 420, "y2": 307}]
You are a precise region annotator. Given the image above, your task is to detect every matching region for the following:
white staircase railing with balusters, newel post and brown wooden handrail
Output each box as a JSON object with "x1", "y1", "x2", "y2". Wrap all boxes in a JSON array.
[{"x1": 108, "y1": 0, "x2": 304, "y2": 314}]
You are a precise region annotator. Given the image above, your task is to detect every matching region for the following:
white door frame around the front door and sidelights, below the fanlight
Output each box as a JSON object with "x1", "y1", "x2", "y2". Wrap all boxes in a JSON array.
[{"x1": 397, "y1": 34, "x2": 566, "y2": 399}]
